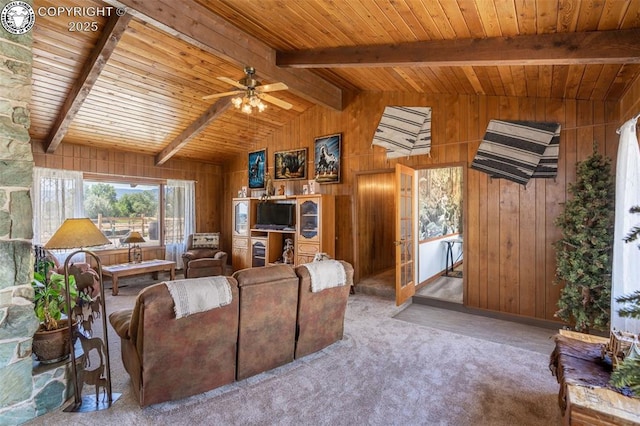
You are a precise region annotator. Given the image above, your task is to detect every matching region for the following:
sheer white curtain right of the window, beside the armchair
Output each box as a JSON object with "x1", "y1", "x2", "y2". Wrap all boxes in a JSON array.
[{"x1": 164, "y1": 180, "x2": 196, "y2": 269}]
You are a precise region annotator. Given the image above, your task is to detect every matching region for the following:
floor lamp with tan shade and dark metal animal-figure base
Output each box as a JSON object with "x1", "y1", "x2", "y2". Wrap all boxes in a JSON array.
[{"x1": 44, "y1": 218, "x2": 120, "y2": 412}]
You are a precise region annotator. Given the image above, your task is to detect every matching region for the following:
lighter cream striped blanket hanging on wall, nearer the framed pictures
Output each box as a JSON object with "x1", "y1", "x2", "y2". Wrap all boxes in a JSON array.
[{"x1": 372, "y1": 106, "x2": 431, "y2": 159}]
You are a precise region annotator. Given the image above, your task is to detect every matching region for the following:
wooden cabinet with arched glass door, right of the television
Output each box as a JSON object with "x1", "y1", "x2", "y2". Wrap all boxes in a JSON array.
[{"x1": 295, "y1": 194, "x2": 336, "y2": 265}]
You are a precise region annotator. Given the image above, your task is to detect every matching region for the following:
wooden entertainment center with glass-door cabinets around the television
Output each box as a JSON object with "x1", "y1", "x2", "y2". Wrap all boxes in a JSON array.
[{"x1": 231, "y1": 194, "x2": 335, "y2": 271}]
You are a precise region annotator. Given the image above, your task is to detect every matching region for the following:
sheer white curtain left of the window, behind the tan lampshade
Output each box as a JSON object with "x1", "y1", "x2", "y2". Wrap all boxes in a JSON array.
[{"x1": 31, "y1": 167, "x2": 84, "y2": 263}]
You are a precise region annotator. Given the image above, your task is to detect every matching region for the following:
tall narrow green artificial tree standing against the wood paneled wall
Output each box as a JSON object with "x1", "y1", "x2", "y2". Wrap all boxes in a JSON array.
[{"x1": 554, "y1": 143, "x2": 615, "y2": 333}]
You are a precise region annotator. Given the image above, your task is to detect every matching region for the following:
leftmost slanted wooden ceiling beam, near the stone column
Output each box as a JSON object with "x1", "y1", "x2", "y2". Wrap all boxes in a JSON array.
[{"x1": 43, "y1": 14, "x2": 132, "y2": 154}]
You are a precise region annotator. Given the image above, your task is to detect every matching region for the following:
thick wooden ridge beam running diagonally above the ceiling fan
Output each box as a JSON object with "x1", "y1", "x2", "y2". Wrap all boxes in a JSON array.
[{"x1": 105, "y1": 0, "x2": 343, "y2": 111}]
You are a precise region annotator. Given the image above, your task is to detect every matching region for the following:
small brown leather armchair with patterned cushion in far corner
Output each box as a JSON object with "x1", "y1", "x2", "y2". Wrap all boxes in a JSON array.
[{"x1": 182, "y1": 233, "x2": 228, "y2": 278}]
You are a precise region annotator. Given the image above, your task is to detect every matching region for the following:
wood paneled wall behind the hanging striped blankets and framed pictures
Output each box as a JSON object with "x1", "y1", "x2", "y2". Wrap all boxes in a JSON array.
[{"x1": 222, "y1": 92, "x2": 619, "y2": 319}]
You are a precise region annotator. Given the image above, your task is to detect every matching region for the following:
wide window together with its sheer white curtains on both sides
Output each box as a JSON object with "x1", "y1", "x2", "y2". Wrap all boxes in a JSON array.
[{"x1": 32, "y1": 167, "x2": 195, "y2": 269}]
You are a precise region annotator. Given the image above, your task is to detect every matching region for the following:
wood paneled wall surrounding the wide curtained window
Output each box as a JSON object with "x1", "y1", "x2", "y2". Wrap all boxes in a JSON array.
[{"x1": 32, "y1": 143, "x2": 224, "y2": 265}]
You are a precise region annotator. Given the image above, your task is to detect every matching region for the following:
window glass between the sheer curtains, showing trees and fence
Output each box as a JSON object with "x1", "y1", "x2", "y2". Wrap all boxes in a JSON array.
[{"x1": 83, "y1": 180, "x2": 161, "y2": 248}]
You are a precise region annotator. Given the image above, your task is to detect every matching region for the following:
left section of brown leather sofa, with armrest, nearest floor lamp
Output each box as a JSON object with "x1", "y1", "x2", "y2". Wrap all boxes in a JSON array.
[{"x1": 109, "y1": 277, "x2": 239, "y2": 407}]
